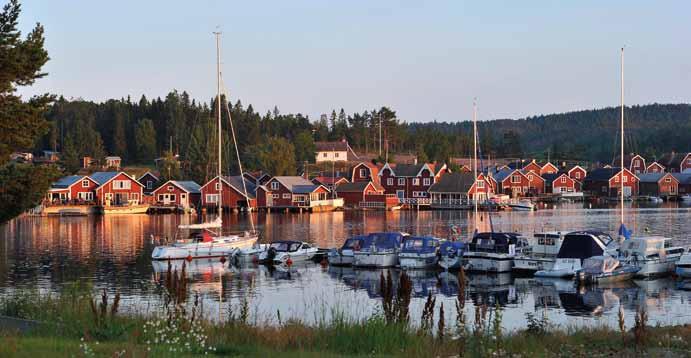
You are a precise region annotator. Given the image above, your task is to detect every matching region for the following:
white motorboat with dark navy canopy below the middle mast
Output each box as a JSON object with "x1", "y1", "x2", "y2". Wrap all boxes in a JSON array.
[{"x1": 463, "y1": 232, "x2": 529, "y2": 272}]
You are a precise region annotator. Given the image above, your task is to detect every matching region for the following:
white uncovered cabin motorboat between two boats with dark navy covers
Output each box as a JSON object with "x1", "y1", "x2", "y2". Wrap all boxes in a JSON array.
[{"x1": 512, "y1": 231, "x2": 564, "y2": 273}]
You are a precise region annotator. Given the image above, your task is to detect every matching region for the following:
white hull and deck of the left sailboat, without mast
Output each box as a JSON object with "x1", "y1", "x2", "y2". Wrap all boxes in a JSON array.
[{"x1": 151, "y1": 229, "x2": 259, "y2": 260}]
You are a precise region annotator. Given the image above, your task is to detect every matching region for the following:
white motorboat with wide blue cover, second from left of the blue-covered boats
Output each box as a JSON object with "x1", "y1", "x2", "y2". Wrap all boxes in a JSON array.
[{"x1": 353, "y1": 232, "x2": 407, "y2": 267}]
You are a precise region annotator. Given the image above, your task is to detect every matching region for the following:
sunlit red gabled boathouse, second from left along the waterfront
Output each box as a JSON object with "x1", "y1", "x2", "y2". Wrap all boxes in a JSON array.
[{"x1": 90, "y1": 172, "x2": 144, "y2": 206}]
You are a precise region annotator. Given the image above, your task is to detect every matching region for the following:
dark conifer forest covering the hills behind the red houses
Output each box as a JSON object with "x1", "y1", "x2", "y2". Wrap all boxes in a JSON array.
[{"x1": 34, "y1": 91, "x2": 691, "y2": 182}]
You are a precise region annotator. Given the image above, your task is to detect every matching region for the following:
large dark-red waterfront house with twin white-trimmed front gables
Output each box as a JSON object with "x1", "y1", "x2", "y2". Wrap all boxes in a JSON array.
[{"x1": 379, "y1": 163, "x2": 437, "y2": 203}]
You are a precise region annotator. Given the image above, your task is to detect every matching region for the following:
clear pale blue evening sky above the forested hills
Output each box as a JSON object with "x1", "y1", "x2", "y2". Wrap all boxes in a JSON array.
[{"x1": 14, "y1": 0, "x2": 691, "y2": 122}]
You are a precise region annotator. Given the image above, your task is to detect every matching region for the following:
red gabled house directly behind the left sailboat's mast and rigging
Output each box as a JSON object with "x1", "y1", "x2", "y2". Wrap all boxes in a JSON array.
[{"x1": 199, "y1": 175, "x2": 257, "y2": 209}]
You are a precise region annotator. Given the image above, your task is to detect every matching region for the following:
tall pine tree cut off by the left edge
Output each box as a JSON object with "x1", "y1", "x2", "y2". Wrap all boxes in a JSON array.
[{"x1": 0, "y1": 0, "x2": 58, "y2": 223}]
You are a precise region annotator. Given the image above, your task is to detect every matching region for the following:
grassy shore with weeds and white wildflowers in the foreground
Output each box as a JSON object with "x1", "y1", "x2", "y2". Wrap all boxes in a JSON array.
[{"x1": 0, "y1": 278, "x2": 691, "y2": 357}]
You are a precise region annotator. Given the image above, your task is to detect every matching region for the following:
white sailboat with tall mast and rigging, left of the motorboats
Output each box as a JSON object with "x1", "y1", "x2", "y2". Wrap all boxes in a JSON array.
[{"x1": 151, "y1": 32, "x2": 259, "y2": 260}]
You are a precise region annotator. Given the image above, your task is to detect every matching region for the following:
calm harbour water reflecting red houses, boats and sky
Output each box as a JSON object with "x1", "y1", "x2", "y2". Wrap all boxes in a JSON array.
[{"x1": 0, "y1": 204, "x2": 691, "y2": 329}]
